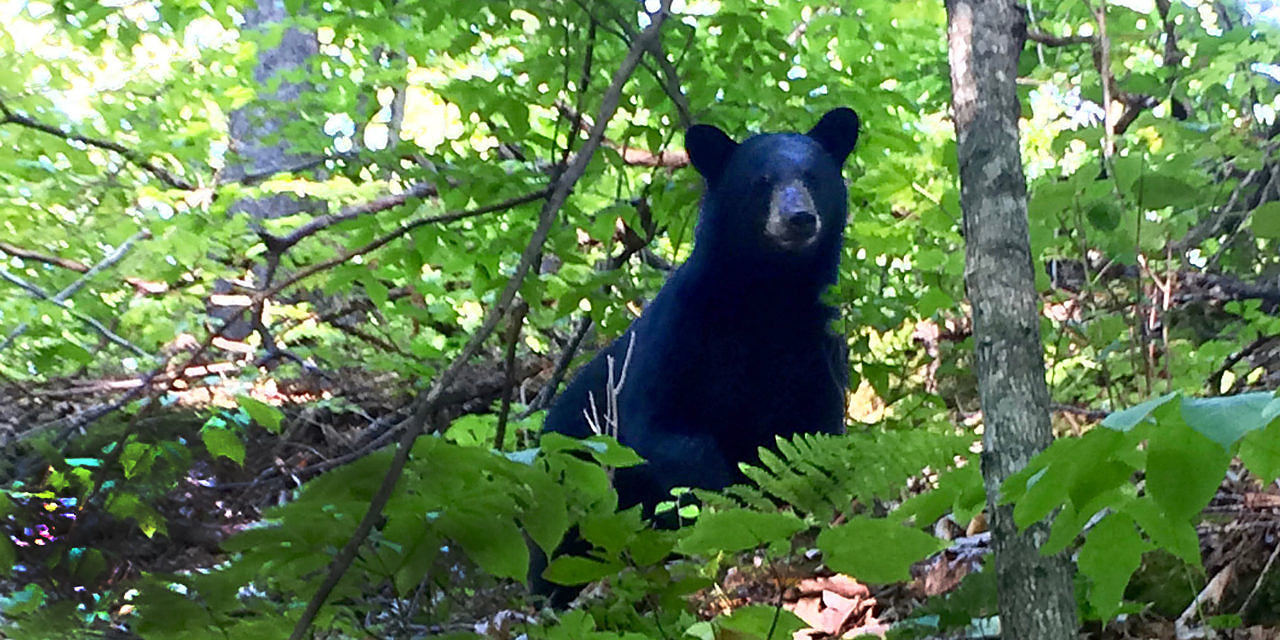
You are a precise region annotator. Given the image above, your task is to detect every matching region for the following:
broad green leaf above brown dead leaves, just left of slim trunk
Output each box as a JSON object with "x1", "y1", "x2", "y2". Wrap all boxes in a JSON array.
[{"x1": 818, "y1": 516, "x2": 946, "y2": 584}]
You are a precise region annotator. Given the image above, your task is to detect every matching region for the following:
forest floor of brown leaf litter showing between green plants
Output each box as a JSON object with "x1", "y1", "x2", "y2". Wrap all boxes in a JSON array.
[{"x1": 0, "y1": 361, "x2": 1280, "y2": 640}]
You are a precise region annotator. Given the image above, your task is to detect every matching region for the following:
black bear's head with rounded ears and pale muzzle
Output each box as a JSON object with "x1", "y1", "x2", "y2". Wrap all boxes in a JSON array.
[{"x1": 685, "y1": 108, "x2": 859, "y2": 288}]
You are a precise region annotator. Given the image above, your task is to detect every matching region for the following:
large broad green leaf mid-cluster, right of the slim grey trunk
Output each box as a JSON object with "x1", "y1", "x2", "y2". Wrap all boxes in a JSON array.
[{"x1": 1147, "y1": 406, "x2": 1231, "y2": 520}]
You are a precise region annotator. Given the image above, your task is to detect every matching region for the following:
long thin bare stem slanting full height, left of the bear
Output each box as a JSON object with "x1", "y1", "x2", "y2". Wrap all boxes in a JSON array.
[{"x1": 289, "y1": 0, "x2": 672, "y2": 640}]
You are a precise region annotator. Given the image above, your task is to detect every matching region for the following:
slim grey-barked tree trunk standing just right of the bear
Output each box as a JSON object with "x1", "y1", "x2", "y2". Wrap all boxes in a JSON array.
[{"x1": 946, "y1": 0, "x2": 1078, "y2": 640}]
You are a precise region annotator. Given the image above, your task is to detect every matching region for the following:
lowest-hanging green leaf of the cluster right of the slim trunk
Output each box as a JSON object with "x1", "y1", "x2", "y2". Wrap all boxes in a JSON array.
[{"x1": 1078, "y1": 513, "x2": 1151, "y2": 620}]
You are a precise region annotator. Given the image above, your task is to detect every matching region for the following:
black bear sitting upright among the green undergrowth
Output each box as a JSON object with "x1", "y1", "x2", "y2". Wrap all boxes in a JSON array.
[{"x1": 544, "y1": 108, "x2": 859, "y2": 515}]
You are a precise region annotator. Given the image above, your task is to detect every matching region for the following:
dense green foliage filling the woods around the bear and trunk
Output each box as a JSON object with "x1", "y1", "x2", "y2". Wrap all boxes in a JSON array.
[{"x1": 0, "y1": 0, "x2": 1280, "y2": 637}]
